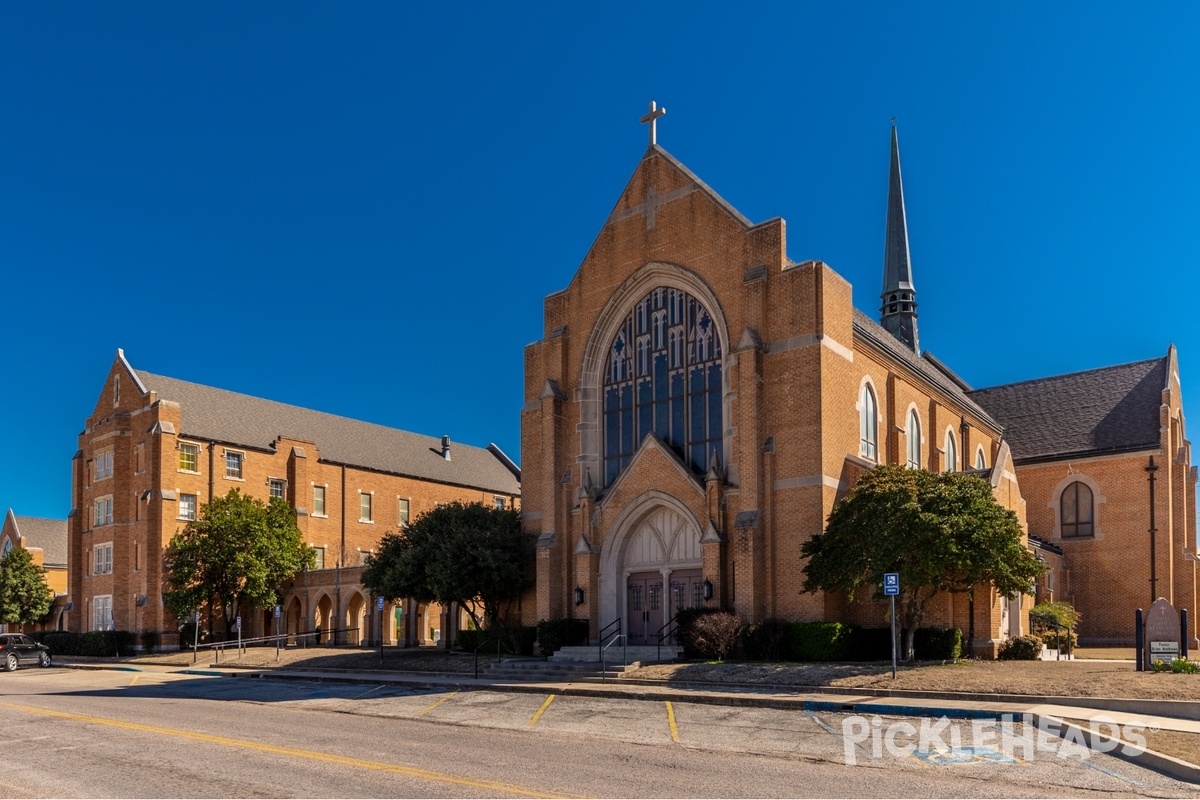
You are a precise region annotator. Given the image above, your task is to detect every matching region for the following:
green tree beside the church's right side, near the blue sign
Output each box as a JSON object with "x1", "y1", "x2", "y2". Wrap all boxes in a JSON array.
[{"x1": 800, "y1": 464, "x2": 1044, "y2": 658}]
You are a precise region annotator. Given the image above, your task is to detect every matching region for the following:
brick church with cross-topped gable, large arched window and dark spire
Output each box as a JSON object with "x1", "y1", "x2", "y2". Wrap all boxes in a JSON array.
[{"x1": 521, "y1": 104, "x2": 1196, "y2": 655}]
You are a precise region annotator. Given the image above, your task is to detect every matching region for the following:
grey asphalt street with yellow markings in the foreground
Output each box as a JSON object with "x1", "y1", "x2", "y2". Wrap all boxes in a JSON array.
[{"x1": 0, "y1": 668, "x2": 1196, "y2": 798}]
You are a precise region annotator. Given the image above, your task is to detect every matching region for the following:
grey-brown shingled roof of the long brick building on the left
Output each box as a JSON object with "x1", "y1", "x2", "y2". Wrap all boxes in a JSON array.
[{"x1": 134, "y1": 371, "x2": 521, "y2": 494}]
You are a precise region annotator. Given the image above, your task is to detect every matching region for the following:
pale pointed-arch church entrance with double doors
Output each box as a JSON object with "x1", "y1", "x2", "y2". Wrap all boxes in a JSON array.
[{"x1": 598, "y1": 492, "x2": 703, "y2": 644}]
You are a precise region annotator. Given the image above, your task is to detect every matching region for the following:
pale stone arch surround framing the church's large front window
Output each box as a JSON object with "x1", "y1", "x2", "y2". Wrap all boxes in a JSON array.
[{"x1": 575, "y1": 261, "x2": 733, "y2": 491}]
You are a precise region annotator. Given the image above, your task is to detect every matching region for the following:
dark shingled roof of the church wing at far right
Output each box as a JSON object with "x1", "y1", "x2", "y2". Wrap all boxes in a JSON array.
[{"x1": 970, "y1": 357, "x2": 1168, "y2": 464}]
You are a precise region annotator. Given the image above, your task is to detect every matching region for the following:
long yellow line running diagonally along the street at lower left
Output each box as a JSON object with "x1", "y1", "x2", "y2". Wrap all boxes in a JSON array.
[{"x1": 0, "y1": 703, "x2": 580, "y2": 798}]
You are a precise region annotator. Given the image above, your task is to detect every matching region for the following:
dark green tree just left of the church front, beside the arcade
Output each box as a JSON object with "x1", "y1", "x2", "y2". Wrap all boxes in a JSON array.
[{"x1": 362, "y1": 503, "x2": 534, "y2": 630}]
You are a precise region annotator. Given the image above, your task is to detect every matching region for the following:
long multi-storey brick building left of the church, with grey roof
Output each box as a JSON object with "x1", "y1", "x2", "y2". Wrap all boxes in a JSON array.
[{"x1": 67, "y1": 350, "x2": 521, "y2": 645}]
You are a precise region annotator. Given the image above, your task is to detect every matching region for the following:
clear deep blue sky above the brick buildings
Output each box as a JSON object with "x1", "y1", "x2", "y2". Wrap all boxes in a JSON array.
[{"x1": 0, "y1": 1, "x2": 1200, "y2": 517}]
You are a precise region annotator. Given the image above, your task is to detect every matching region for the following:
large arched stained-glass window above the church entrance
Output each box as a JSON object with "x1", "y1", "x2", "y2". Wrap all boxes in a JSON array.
[{"x1": 604, "y1": 287, "x2": 722, "y2": 486}]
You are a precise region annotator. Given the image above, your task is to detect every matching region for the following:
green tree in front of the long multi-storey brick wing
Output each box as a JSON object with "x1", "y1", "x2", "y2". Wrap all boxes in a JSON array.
[{"x1": 163, "y1": 489, "x2": 313, "y2": 633}]
